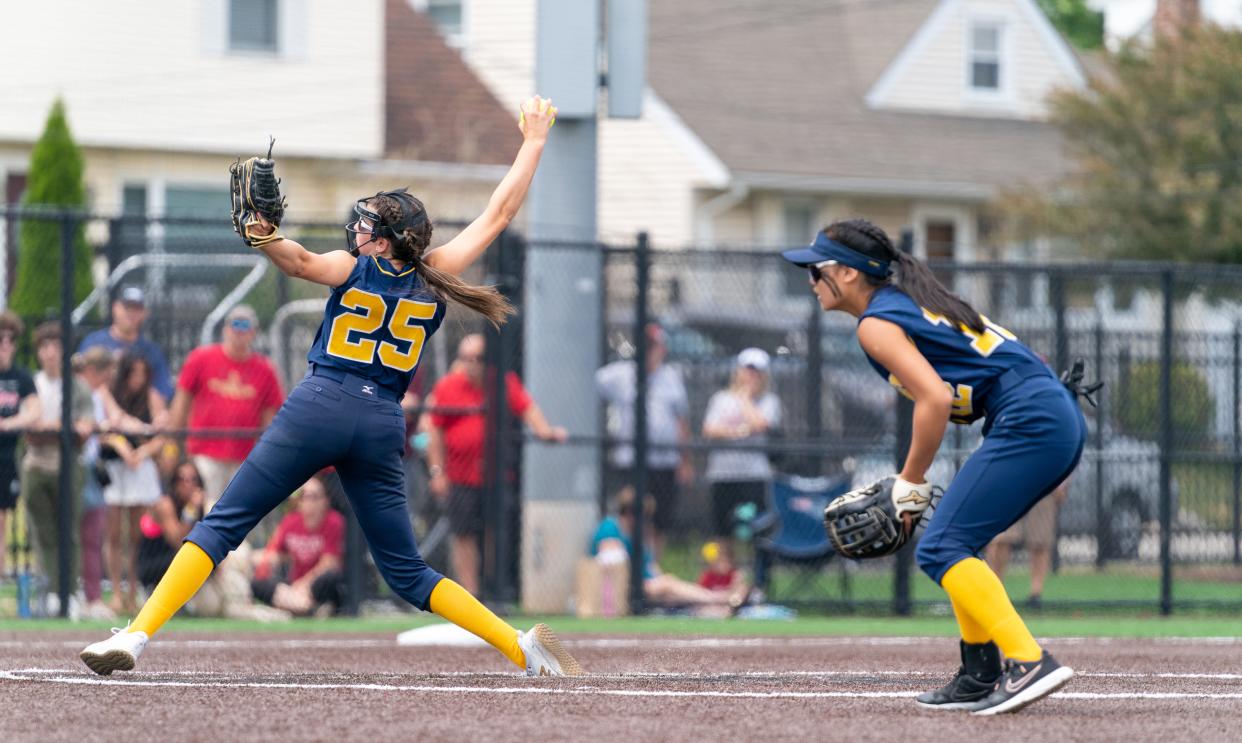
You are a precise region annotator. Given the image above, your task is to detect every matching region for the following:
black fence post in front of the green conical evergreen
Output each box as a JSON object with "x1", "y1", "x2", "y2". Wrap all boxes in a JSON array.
[{"x1": 57, "y1": 212, "x2": 77, "y2": 619}]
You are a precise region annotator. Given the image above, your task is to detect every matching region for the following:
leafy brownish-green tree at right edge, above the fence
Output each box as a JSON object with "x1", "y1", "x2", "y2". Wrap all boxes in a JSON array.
[{"x1": 1006, "y1": 26, "x2": 1242, "y2": 263}]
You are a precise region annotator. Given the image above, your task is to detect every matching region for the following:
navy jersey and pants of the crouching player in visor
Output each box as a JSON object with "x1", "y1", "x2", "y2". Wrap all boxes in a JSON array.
[{"x1": 858, "y1": 286, "x2": 1087, "y2": 583}]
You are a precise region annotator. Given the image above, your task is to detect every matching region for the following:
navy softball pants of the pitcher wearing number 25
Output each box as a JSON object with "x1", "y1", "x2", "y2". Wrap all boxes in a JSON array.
[{"x1": 185, "y1": 374, "x2": 443, "y2": 611}]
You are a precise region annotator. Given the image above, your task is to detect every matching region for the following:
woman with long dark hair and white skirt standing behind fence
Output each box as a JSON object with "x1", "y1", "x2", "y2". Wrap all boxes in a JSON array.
[{"x1": 99, "y1": 352, "x2": 165, "y2": 613}]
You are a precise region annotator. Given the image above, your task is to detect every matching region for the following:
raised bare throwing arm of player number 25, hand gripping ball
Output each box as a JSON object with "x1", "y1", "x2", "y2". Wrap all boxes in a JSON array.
[{"x1": 426, "y1": 96, "x2": 556, "y2": 276}]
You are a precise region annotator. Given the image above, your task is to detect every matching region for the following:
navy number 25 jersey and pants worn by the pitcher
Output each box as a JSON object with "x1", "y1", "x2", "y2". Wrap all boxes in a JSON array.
[{"x1": 186, "y1": 256, "x2": 445, "y2": 610}]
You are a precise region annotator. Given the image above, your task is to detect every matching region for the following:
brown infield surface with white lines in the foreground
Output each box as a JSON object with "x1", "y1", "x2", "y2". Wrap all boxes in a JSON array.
[{"x1": 0, "y1": 631, "x2": 1242, "y2": 743}]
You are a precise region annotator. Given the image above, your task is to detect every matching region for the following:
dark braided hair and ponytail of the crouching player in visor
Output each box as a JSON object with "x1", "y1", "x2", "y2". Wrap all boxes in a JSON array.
[{"x1": 823, "y1": 219, "x2": 985, "y2": 333}]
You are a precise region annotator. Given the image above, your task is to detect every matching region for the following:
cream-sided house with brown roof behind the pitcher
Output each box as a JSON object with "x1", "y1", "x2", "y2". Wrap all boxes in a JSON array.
[{"x1": 0, "y1": 0, "x2": 520, "y2": 303}]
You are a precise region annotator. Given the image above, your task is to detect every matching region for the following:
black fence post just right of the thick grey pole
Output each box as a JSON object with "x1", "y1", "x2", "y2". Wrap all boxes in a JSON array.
[{"x1": 630, "y1": 232, "x2": 651, "y2": 614}]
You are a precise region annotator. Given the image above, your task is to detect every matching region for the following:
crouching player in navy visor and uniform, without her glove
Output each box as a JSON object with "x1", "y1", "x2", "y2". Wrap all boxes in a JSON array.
[{"x1": 784, "y1": 219, "x2": 1086, "y2": 714}]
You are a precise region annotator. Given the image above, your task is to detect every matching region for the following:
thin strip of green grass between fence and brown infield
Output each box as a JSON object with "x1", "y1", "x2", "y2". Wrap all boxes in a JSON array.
[{"x1": 0, "y1": 614, "x2": 1242, "y2": 637}]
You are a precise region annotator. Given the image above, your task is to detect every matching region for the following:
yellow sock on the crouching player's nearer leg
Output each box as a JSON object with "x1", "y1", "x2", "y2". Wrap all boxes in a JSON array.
[{"x1": 940, "y1": 558, "x2": 1043, "y2": 662}]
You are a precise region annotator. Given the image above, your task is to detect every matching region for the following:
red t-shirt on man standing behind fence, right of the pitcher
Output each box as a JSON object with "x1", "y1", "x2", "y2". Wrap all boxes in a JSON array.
[{"x1": 431, "y1": 372, "x2": 530, "y2": 487}]
